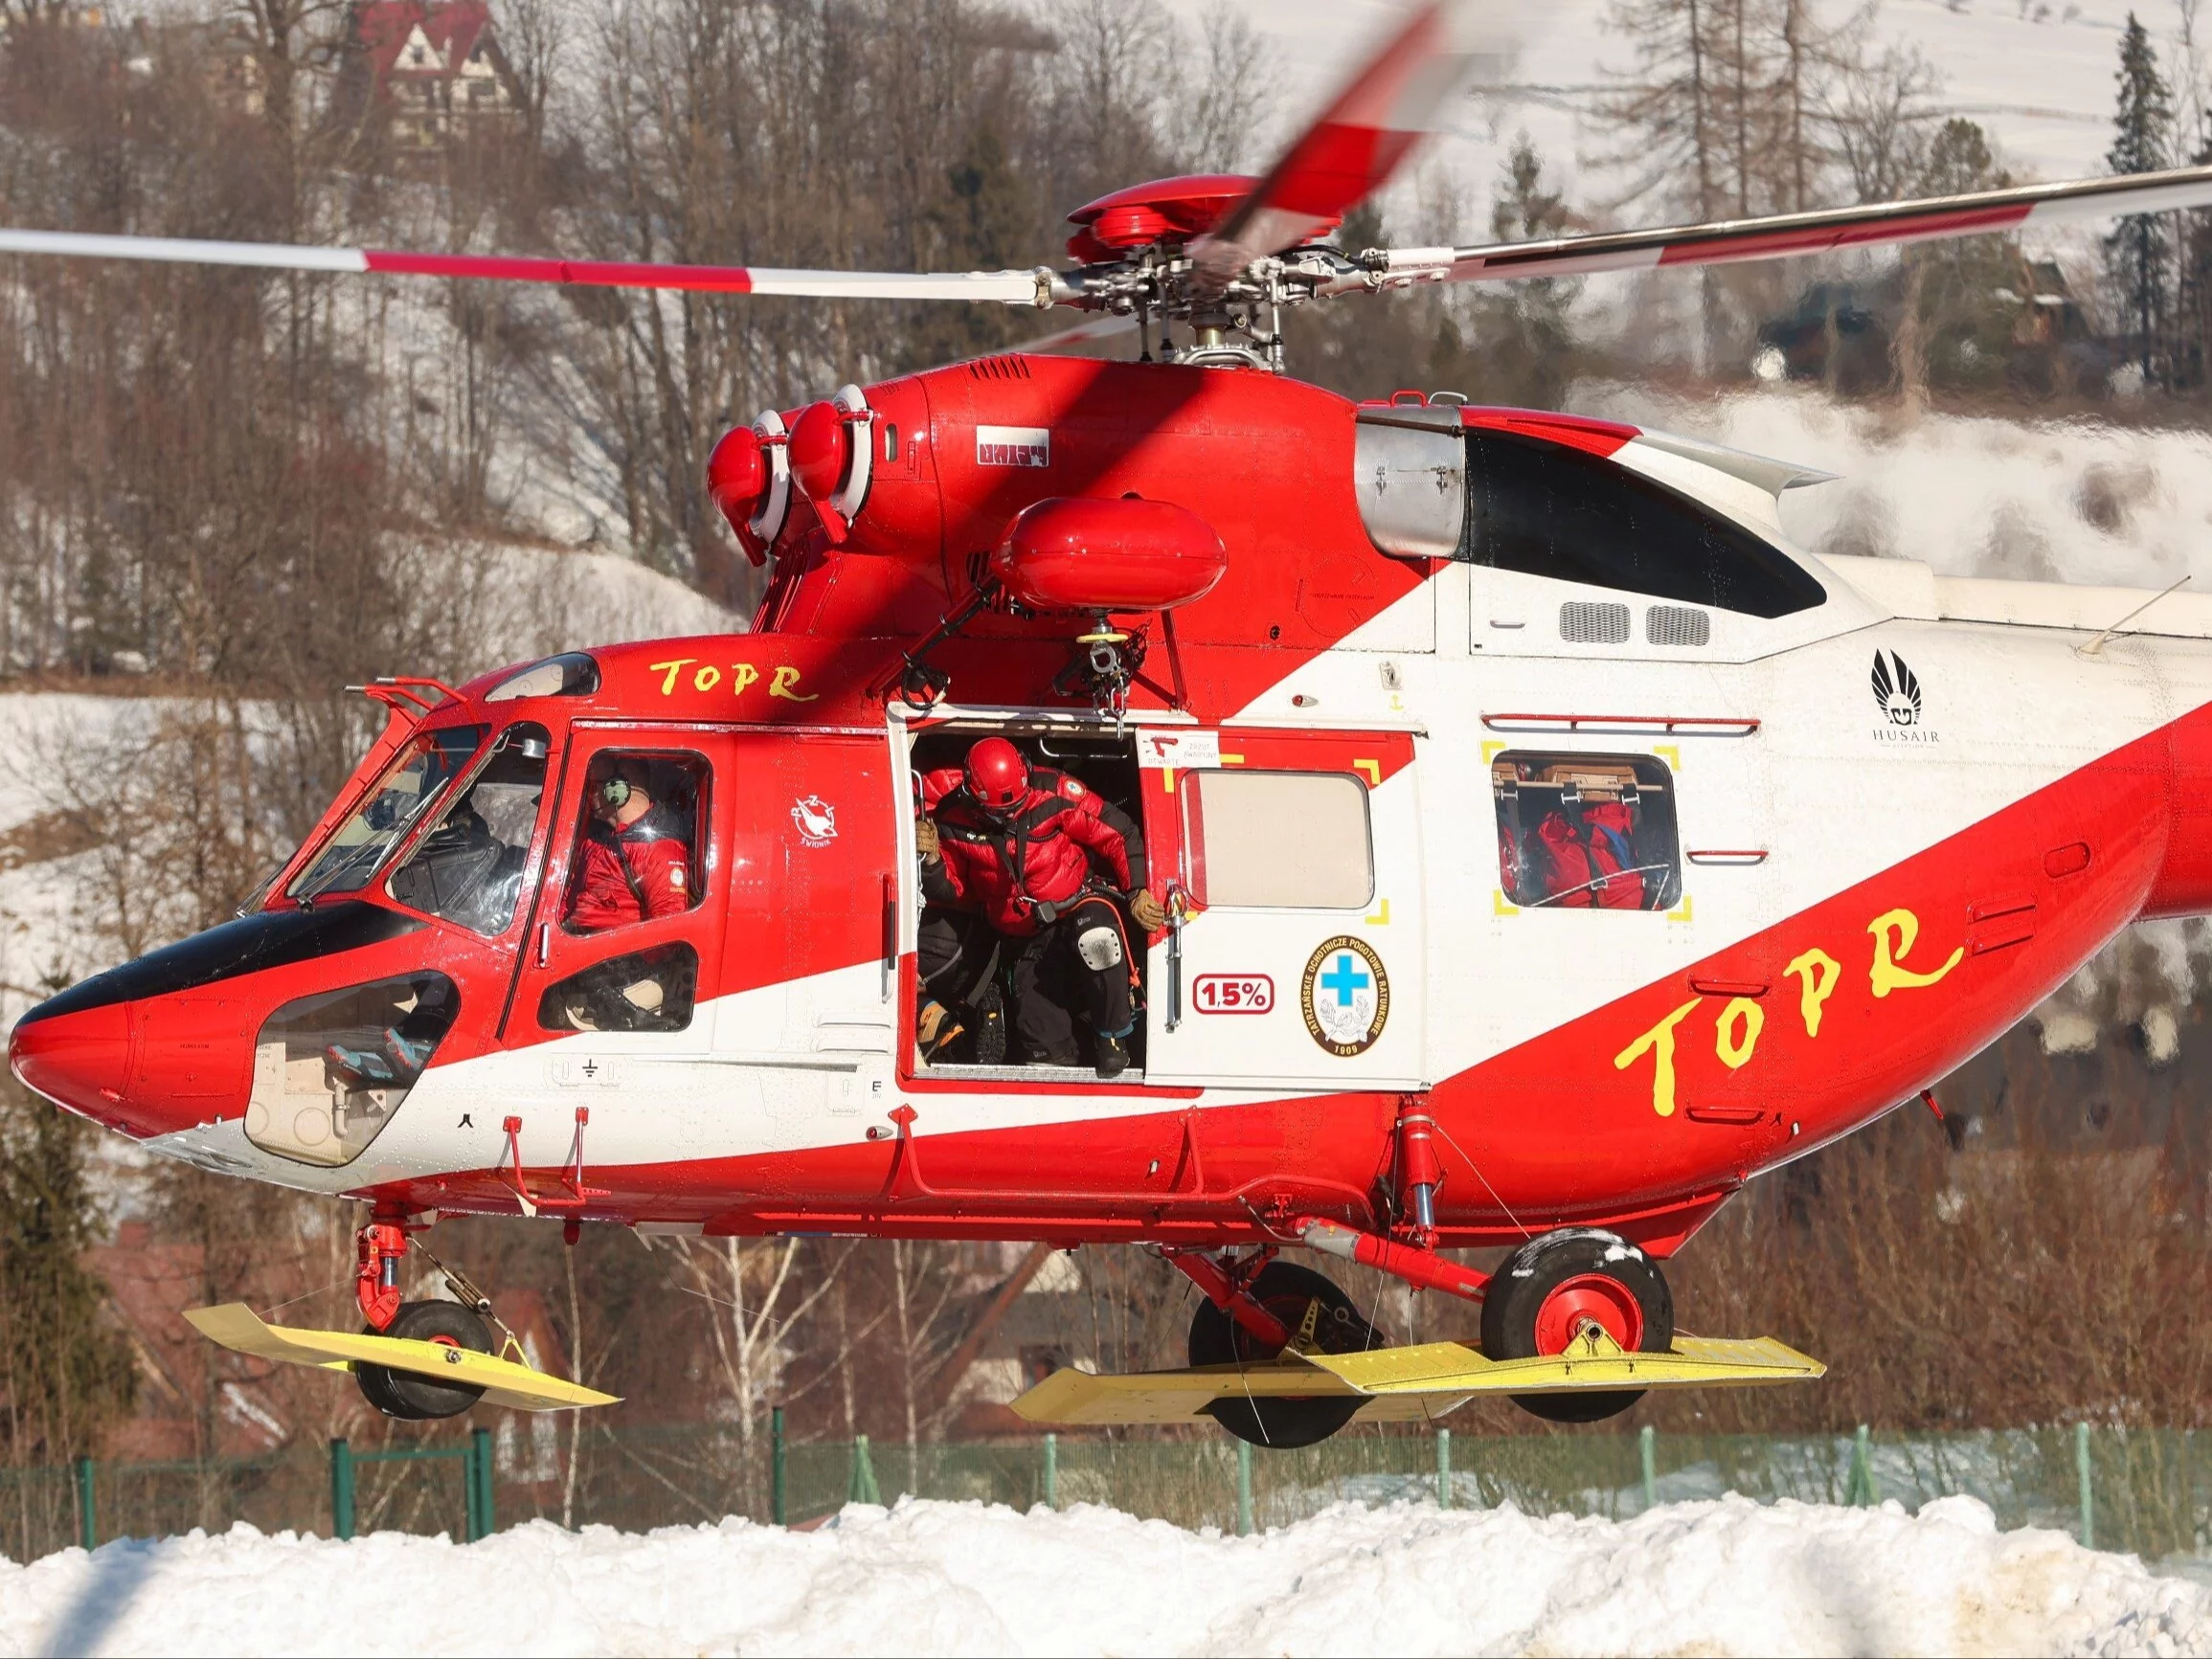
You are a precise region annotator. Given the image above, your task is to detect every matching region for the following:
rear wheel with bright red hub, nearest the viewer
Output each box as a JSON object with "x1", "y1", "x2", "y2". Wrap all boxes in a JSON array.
[{"x1": 1482, "y1": 1227, "x2": 1675, "y2": 1423}]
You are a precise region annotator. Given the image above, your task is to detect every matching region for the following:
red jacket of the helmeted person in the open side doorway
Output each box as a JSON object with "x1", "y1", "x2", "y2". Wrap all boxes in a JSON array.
[{"x1": 922, "y1": 765, "x2": 1141, "y2": 938}]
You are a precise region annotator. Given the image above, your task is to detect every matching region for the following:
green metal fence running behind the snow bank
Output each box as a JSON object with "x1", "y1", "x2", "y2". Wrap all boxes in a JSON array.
[{"x1": 0, "y1": 1414, "x2": 2212, "y2": 1561}]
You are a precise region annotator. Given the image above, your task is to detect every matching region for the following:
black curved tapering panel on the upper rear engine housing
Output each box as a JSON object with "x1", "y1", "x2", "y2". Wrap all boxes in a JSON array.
[{"x1": 1457, "y1": 429, "x2": 1827, "y2": 617}]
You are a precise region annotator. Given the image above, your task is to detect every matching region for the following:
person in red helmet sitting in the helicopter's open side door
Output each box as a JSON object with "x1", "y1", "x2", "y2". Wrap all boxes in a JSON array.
[{"x1": 915, "y1": 736, "x2": 1168, "y2": 1077}]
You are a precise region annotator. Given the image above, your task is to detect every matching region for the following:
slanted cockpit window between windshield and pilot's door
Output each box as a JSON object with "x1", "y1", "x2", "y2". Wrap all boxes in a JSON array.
[{"x1": 392, "y1": 724, "x2": 551, "y2": 935}]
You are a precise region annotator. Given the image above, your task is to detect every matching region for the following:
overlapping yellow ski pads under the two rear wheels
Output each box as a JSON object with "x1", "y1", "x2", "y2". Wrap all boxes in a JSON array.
[{"x1": 1013, "y1": 1327, "x2": 1827, "y2": 1424}]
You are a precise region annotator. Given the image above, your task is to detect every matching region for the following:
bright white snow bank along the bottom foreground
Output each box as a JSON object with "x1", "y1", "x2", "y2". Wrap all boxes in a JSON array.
[{"x1": 0, "y1": 1497, "x2": 2212, "y2": 1654}]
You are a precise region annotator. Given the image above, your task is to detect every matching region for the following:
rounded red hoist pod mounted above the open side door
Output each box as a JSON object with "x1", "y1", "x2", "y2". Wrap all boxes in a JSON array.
[{"x1": 991, "y1": 496, "x2": 1230, "y2": 611}]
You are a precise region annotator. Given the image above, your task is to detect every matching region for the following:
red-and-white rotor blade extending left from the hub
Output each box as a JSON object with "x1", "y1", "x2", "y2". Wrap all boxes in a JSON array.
[{"x1": 0, "y1": 230, "x2": 1053, "y2": 305}]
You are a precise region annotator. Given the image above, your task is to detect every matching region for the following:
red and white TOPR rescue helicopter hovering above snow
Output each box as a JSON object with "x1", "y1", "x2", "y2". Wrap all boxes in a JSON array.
[{"x1": 12, "y1": 0, "x2": 2212, "y2": 1445}]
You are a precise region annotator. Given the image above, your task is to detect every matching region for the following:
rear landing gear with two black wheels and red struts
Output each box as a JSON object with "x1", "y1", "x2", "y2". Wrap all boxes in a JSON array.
[{"x1": 1165, "y1": 1221, "x2": 1675, "y2": 1448}]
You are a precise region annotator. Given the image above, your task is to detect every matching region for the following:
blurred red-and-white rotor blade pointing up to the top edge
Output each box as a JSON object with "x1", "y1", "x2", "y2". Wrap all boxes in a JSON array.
[{"x1": 1192, "y1": 0, "x2": 1496, "y2": 280}]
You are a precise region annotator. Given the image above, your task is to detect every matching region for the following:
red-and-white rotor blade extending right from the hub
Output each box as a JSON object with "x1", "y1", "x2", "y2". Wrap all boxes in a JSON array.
[{"x1": 1371, "y1": 166, "x2": 2212, "y2": 287}]
